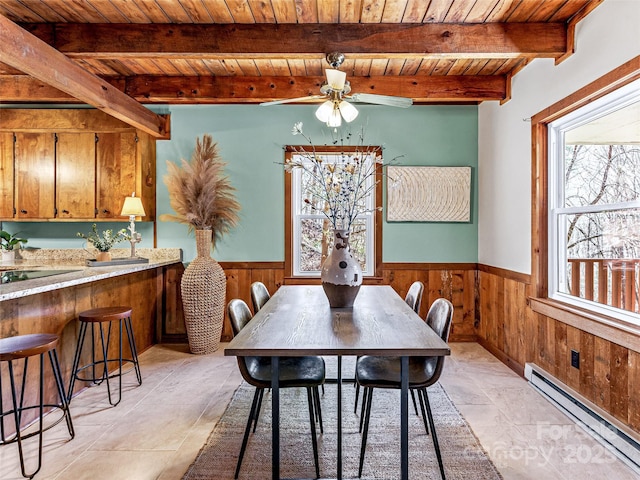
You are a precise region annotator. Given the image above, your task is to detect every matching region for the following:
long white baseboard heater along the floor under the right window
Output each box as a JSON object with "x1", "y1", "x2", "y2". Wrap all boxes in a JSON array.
[{"x1": 524, "y1": 363, "x2": 640, "y2": 474}]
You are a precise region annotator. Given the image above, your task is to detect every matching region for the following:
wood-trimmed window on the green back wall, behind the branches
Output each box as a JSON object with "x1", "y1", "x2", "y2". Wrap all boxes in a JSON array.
[{"x1": 285, "y1": 146, "x2": 382, "y2": 277}]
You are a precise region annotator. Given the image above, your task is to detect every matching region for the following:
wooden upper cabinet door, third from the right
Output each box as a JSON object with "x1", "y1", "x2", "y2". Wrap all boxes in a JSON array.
[{"x1": 14, "y1": 133, "x2": 55, "y2": 219}]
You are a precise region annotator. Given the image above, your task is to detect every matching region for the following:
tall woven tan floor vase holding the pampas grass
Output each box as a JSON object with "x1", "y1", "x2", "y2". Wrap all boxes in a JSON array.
[{"x1": 180, "y1": 229, "x2": 227, "y2": 354}]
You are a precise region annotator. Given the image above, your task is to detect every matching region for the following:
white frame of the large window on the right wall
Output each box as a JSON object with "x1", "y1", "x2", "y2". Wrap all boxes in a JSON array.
[{"x1": 548, "y1": 80, "x2": 640, "y2": 325}]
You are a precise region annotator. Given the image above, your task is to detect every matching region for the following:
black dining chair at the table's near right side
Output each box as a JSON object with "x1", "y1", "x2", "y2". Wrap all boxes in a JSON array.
[{"x1": 356, "y1": 298, "x2": 453, "y2": 480}]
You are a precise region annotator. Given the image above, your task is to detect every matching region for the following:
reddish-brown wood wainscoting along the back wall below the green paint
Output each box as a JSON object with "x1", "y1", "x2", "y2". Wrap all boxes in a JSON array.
[{"x1": 160, "y1": 262, "x2": 477, "y2": 343}]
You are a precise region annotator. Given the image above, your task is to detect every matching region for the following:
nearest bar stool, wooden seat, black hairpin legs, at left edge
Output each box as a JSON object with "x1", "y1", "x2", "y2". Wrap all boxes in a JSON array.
[{"x1": 0, "y1": 333, "x2": 75, "y2": 478}]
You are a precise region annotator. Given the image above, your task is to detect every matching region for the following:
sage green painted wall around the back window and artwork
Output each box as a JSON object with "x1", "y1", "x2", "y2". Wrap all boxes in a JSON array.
[{"x1": 3, "y1": 105, "x2": 478, "y2": 262}]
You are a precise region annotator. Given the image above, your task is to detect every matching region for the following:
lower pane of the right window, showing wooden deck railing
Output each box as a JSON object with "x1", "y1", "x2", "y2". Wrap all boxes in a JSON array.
[{"x1": 559, "y1": 209, "x2": 640, "y2": 313}]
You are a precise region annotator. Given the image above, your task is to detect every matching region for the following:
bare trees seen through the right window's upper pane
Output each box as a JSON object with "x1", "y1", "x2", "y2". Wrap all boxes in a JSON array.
[{"x1": 564, "y1": 145, "x2": 640, "y2": 207}]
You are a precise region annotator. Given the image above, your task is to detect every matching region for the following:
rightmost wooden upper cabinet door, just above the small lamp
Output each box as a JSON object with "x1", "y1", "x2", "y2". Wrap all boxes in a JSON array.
[{"x1": 96, "y1": 132, "x2": 140, "y2": 220}]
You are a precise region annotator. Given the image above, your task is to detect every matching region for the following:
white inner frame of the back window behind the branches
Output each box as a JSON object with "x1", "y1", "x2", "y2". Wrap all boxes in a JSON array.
[{"x1": 291, "y1": 150, "x2": 376, "y2": 277}]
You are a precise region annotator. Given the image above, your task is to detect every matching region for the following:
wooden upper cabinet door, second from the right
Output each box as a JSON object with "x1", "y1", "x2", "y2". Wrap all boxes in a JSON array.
[{"x1": 56, "y1": 133, "x2": 96, "y2": 219}]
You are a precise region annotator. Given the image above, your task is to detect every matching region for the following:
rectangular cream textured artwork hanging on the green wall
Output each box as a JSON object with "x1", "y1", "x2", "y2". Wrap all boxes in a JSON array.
[{"x1": 387, "y1": 166, "x2": 471, "y2": 222}]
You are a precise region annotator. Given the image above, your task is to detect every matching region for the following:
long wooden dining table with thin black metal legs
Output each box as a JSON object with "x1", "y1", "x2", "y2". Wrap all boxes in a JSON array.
[{"x1": 224, "y1": 285, "x2": 450, "y2": 480}]
